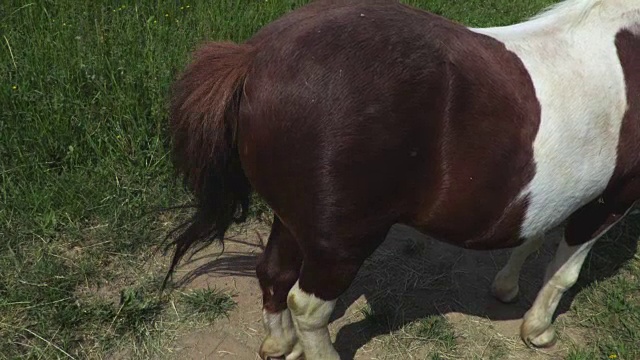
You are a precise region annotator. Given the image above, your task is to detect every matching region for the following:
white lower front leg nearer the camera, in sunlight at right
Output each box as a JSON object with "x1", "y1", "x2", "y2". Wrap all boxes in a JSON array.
[{"x1": 520, "y1": 238, "x2": 597, "y2": 347}]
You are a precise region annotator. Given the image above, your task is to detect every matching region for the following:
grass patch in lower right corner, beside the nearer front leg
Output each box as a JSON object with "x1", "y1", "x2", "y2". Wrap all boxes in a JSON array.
[{"x1": 567, "y1": 219, "x2": 640, "y2": 360}]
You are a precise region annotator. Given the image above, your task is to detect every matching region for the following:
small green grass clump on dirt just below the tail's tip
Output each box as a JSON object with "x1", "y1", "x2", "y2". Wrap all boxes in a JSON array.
[{"x1": 181, "y1": 288, "x2": 237, "y2": 321}]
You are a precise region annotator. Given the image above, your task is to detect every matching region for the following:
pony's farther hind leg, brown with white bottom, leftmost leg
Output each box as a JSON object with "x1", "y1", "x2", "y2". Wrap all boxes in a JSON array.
[{"x1": 256, "y1": 217, "x2": 302, "y2": 359}]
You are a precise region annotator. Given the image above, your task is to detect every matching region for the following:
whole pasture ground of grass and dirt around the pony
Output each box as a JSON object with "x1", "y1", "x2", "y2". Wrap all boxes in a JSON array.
[{"x1": 0, "y1": 0, "x2": 640, "y2": 360}]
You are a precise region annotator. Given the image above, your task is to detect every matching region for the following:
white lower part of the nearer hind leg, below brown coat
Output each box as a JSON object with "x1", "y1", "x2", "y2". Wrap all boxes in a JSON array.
[{"x1": 287, "y1": 282, "x2": 340, "y2": 360}]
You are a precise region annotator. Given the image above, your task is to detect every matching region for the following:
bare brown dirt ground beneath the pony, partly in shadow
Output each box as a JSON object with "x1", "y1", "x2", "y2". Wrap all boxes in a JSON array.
[{"x1": 168, "y1": 224, "x2": 583, "y2": 360}]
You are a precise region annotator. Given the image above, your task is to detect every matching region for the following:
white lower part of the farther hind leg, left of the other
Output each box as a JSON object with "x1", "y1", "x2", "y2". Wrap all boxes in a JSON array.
[{"x1": 260, "y1": 309, "x2": 298, "y2": 359}]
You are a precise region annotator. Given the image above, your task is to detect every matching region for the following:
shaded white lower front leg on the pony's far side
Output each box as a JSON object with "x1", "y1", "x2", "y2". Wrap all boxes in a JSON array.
[{"x1": 491, "y1": 235, "x2": 545, "y2": 303}]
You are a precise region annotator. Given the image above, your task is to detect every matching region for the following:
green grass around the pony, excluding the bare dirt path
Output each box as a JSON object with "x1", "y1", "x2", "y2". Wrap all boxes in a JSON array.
[{"x1": 0, "y1": 0, "x2": 640, "y2": 359}]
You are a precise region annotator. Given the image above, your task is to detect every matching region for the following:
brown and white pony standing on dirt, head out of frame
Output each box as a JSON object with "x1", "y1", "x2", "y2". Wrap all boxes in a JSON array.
[{"x1": 169, "y1": 0, "x2": 640, "y2": 360}]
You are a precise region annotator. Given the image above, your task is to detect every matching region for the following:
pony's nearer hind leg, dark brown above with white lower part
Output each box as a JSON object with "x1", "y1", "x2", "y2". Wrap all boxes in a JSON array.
[{"x1": 287, "y1": 229, "x2": 388, "y2": 360}]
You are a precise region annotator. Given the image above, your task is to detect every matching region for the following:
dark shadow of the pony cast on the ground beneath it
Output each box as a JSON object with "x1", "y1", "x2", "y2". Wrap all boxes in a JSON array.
[{"x1": 176, "y1": 213, "x2": 640, "y2": 359}]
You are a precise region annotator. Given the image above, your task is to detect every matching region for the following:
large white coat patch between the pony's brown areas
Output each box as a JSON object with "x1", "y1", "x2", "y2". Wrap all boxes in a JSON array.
[{"x1": 471, "y1": 0, "x2": 640, "y2": 238}]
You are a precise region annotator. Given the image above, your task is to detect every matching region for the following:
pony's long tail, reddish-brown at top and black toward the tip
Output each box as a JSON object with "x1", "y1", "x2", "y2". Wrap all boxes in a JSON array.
[{"x1": 162, "y1": 42, "x2": 252, "y2": 289}]
